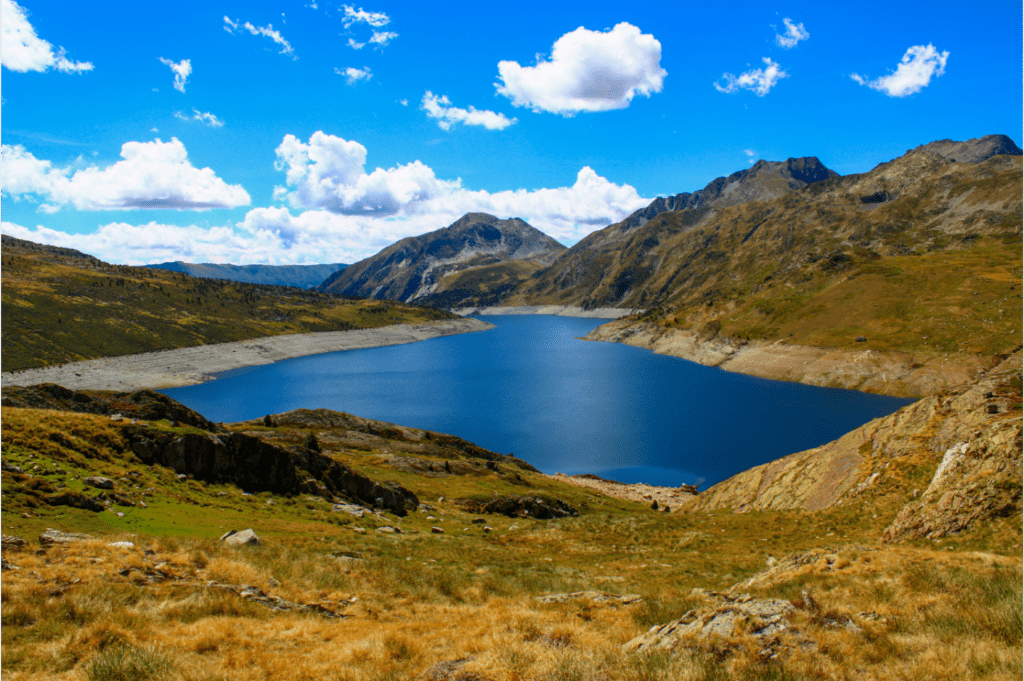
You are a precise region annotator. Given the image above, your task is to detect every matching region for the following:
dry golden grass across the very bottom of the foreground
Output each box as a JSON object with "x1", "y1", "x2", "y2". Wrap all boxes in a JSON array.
[{"x1": 2, "y1": 524, "x2": 1022, "y2": 681}]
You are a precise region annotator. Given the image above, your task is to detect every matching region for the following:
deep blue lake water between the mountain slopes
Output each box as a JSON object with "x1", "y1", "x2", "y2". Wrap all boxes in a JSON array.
[{"x1": 163, "y1": 315, "x2": 912, "y2": 488}]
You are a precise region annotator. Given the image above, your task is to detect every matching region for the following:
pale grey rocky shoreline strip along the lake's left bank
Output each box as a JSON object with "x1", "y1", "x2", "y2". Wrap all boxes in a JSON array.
[{"x1": 0, "y1": 318, "x2": 494, "y2": 391}]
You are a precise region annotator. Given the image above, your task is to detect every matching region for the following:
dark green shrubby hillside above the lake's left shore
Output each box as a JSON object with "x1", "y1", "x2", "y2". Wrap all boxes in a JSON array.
[{"x1": 0, "y1": 236, "x2": 454, "y2": 371}]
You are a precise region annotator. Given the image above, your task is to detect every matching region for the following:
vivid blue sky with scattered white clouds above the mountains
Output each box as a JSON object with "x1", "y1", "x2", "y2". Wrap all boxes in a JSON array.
[{"x1": 0, "y1": 0, "x2": 1024, "y2": 264}]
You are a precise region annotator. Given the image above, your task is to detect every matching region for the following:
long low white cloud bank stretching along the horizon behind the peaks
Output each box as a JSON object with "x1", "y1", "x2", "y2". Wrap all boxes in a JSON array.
[{"x1": 2, "y1": 132, "x2": 650, "y2": 264}]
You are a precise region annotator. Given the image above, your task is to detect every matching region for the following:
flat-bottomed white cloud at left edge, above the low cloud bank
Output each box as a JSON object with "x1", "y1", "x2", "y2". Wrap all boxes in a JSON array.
[{"x1": 0, "y1": 137, "x2": 251, "y2": 212}]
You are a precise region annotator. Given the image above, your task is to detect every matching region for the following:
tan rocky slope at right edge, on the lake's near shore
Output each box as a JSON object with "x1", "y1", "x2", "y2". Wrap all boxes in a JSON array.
[{"x1": 688, "y1": 348, "x2": 1022, "y2": 542}]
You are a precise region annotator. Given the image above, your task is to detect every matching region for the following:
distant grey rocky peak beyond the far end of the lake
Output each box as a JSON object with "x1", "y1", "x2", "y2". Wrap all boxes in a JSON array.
[{"x1": 317, "y1": 213, "x2": 565, "y2": 302}]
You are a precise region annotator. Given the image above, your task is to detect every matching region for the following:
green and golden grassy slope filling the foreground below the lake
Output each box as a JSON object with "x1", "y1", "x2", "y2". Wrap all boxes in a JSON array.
[{"x1": 0, "y1": 387, "x2": 1022, "y2": 681}]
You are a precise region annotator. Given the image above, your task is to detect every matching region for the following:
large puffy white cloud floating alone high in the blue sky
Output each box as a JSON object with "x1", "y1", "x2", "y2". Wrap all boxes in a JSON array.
[{"x1": 495, "y1": 22, "x2": 668, "y2": 116}]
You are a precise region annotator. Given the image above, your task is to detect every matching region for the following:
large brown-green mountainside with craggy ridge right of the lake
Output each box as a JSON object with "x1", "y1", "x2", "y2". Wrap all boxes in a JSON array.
[{"x1": 516, "y1": 152, "x2": 1024, "y2": 353}]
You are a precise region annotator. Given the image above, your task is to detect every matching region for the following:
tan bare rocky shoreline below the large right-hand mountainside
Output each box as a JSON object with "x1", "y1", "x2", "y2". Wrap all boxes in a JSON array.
[{"x1": 585, "y1": 321, "x2": 992, "y2": 397}]
